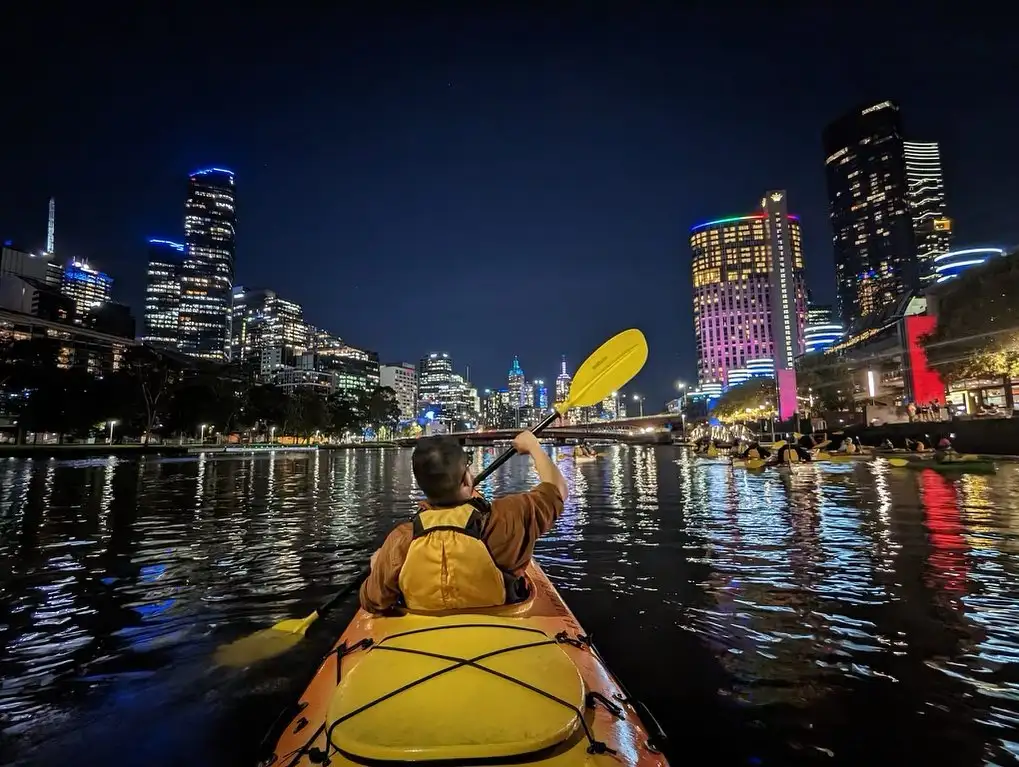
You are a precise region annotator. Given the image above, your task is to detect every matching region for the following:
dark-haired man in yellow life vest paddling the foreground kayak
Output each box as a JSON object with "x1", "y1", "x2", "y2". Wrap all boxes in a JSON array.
[{"x1": 361, "y1": 432, "x2": 567, "y2": 612}]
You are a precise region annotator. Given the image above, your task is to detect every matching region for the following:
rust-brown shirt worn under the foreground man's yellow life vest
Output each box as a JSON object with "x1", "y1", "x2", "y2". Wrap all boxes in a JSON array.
[{"x1": 361, "y1": 482, "x2": 562, "y2": 612}]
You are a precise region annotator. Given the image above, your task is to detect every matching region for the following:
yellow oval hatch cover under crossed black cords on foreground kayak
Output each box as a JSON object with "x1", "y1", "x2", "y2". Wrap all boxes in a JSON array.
[{"x1": 326, "y1": 614, "x2": 587, "y2": 762}]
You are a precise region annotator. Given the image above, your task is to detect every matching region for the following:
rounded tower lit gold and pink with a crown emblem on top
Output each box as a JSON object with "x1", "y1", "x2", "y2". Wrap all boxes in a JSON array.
[{"x1": 690, "y1": 206, "x2": 807, "y2": 388}]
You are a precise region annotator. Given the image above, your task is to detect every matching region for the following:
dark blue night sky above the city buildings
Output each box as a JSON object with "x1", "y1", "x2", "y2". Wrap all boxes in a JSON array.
[{"x1": 0, "y1": 2, "x2": 1019, "y2": 409}]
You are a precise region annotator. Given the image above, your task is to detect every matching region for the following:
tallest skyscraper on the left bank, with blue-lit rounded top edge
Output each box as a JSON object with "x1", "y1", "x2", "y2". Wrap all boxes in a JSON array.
[{"x1": 179, "y1": 168, "x2": 236, "y2": 362}]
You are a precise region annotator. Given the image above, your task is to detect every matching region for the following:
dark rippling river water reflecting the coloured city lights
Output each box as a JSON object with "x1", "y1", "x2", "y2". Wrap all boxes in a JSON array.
[{"x1": 0, "y1": 447, "x2": 1019, "y2": 765}]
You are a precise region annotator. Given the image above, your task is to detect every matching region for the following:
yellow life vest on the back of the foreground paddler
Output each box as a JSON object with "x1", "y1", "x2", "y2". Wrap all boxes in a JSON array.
[{"x1": 399, "y1": 498, "x2": 513, "y2": 611}]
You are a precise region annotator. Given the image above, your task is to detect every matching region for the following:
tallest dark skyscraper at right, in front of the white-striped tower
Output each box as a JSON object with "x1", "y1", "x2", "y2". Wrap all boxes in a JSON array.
[{"x1": 822, "y1": 101, "x2": 919, "y2": 329}]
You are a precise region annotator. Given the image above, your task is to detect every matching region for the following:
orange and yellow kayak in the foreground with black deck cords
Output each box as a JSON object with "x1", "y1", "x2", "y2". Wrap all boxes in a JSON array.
[{"x1": 260, "y1": 561, "x2": 668, "y2": 767}]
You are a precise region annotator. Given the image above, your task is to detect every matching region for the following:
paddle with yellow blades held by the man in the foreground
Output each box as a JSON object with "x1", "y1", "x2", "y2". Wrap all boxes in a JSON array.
[{"x1": 215, "y1": 329, "x2": 647, "y2": 668}]
